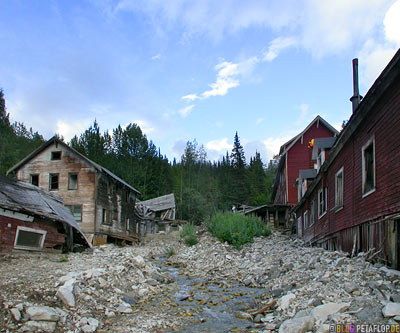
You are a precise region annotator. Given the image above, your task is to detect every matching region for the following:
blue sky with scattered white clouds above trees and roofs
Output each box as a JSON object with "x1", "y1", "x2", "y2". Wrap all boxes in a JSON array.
[{"x1": 0, "y1": 0, "x2": 400, "y2": 162}]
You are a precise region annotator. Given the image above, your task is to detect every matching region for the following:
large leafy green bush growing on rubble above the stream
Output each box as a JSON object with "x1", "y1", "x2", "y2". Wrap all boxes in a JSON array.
[{"x1": 206, "y1": 212, "x2": 271, "y2": 250}]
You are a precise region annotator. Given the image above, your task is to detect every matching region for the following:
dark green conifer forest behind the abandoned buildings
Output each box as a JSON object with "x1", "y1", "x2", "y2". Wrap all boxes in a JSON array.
[{"x1": 0, "y1": 90, "x2": 276, "y2": 223}]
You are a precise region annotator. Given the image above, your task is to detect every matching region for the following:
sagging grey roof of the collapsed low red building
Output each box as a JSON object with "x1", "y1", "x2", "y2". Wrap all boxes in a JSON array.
[{"x1": 0, "y1": 175, "x2": 90, "y2": 246}]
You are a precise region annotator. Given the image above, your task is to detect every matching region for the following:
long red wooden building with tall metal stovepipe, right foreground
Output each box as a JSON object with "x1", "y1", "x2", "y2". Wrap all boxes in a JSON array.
[{"x1": 294, "y1": 51, "x2": 400, "y2": 269}]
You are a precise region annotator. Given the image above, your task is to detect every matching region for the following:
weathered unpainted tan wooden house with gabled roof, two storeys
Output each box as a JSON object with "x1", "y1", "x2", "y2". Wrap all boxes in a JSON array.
[{"x1": 8, "y1": 136, "x2": 140, "y2": 245}]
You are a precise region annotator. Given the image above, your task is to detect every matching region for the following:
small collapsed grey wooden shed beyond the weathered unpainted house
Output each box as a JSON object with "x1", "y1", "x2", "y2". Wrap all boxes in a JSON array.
[{"x1": 135, "y1": 193, "x2": 178, "y2": 236}]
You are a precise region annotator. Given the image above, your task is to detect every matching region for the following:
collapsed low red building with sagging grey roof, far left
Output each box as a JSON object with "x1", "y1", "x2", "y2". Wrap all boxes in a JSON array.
[{"x1": 0, "y1": 175, "x2": 90, "y2": 252}]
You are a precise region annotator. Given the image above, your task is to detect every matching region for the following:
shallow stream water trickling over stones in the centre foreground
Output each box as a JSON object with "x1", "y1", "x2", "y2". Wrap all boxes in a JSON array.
[{"x1": 152, "y1": 257, "x2": 265, "y2": 332}]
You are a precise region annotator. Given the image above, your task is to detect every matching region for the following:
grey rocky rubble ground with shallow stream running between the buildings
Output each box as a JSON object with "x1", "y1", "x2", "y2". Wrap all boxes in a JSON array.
[{"x1": 0, "y1": 230, "x2": 400, "y2": 333}]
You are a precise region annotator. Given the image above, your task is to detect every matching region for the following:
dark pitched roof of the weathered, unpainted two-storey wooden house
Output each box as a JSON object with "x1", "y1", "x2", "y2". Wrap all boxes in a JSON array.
[{"x1": 7, "y1": 136, "x2": 141, "y2": 194}]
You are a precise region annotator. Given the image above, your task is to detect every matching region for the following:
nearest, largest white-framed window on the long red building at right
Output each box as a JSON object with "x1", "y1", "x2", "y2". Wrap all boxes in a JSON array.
[{"x1": 362, "y1": 138, "x2": 375, "y2": 196}]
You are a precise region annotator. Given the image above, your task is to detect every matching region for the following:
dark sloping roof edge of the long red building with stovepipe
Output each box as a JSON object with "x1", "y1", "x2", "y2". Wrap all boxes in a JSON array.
[{"x1": 293, "y1": 49, "x2": 400, "y2": 211}]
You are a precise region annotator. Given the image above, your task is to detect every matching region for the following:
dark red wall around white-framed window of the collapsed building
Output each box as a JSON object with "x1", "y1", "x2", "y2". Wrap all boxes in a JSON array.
[{"x1": 0, "y1": 215, "x2": 65, "y2": 252}]
